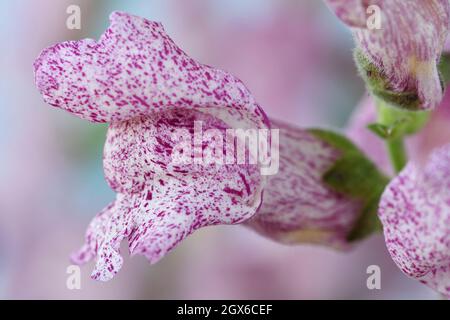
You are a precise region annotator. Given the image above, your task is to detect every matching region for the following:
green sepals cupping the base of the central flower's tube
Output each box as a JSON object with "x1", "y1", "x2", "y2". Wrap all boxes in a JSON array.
[{"x1": 309, "y1": 129, "x2": 389, "y2": 241}]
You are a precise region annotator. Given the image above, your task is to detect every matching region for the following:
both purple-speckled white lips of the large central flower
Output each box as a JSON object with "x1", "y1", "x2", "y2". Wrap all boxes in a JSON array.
[{"x1": 34, "y1": 12, "x2": 269, "y2": 281}]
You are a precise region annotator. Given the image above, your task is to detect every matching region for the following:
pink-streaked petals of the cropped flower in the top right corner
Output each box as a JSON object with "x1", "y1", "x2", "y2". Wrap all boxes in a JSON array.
[{"x1": 327, "y1": 0, "x2": 450, "y2": 109}]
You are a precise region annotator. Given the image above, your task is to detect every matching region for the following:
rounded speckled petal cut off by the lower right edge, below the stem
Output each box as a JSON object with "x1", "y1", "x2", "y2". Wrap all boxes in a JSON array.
[{"x1": 379, "y1": 146, "x2": 450, "y2": 298}]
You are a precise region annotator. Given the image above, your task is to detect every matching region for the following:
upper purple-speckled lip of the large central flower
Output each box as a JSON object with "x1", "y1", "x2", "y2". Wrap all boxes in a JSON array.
[{"x1": 34, "y1": 12, "x2": 267, "y2": 127}]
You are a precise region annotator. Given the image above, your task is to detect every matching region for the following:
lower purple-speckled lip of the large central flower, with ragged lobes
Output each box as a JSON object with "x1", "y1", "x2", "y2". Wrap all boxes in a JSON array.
[{"x1": 73, "y1": 110, "x2": 263, "y2": 281}]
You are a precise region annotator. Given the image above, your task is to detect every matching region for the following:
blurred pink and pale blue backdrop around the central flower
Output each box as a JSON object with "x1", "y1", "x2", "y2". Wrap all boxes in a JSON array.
[{"x1": 0, "y1": 0, "x2": 436, "y2": 299}]
